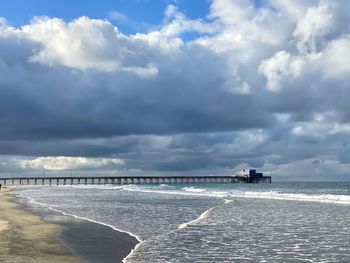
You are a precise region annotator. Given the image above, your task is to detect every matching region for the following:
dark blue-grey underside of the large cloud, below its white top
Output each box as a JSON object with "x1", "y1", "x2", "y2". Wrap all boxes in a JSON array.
[{"x1": 0, "y1": 39, "x2": 275, "y2": 140}]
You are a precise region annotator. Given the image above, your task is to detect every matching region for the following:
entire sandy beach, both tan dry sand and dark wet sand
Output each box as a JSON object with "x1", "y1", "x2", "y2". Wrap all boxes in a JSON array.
[{"x1": 0, "y1": 188, "x2": 137, "y2": 263}]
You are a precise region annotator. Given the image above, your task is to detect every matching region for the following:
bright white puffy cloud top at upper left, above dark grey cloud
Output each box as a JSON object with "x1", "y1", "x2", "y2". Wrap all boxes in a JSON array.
[{"x1": 21, "y1": 17, "x2": 157, "y2": 71}]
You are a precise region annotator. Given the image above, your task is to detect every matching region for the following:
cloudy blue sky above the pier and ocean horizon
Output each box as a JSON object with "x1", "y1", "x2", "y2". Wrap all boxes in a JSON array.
[{"x1": 0, "y1": 0, "x2": 350, "y2": 181}]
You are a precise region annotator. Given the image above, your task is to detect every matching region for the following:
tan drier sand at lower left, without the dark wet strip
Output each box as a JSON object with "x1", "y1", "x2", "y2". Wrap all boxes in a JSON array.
[{"x1": 0, "y1": 188, "x2": 83, "y2": 263}]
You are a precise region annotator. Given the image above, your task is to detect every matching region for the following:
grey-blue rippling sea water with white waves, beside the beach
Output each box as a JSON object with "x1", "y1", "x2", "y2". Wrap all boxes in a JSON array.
[{"x1": 17, "y1": 183, "x2": 350, "y2": 263}]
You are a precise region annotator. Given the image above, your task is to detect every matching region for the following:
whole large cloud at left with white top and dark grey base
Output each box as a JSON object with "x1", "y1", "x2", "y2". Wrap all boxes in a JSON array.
[{"x1": 0, "y1": 14, "x2": 275, "y2": 140}]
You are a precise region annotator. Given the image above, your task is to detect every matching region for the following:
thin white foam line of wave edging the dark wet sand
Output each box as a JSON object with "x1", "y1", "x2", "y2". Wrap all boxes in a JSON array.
[{"x1": 18, "y1": 194, "x2": 143, "y2": 263}]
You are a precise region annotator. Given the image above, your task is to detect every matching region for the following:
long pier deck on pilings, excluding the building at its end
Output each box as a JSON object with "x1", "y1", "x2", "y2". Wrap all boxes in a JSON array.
[{"x1": 0, "y1": 176, "x2": 271, "y2": 185}]
